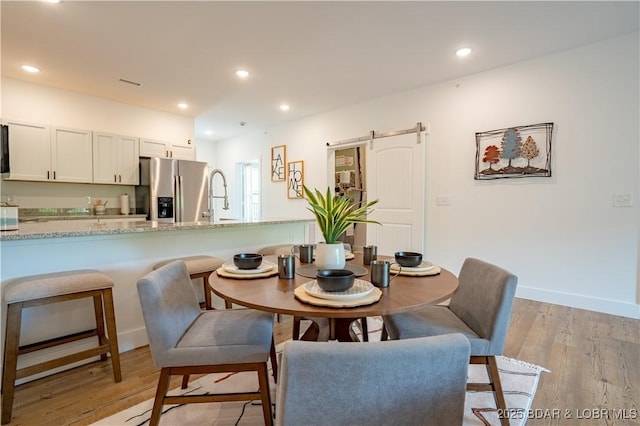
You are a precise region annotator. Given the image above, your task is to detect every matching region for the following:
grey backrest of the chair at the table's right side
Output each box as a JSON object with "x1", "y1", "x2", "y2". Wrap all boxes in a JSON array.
[{"x1": 449, "y1": 258, "x2": 518, "y2": 355}]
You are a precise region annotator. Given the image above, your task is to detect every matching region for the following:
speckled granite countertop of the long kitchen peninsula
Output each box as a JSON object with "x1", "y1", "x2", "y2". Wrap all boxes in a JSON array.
[{"x1": 0, "y1": 215, "x2": 313, "y2": 241}]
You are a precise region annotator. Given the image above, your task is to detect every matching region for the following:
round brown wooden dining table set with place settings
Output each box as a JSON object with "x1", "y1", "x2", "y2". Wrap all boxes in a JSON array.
[{"x1": 209, "y1": 252, "x2": 458, "y2": 341}]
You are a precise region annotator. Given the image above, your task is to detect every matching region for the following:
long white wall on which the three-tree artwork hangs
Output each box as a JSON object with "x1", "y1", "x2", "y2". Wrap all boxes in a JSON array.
[{"x1": 198, "y1": 33, "x2": 640, "y2": 318}]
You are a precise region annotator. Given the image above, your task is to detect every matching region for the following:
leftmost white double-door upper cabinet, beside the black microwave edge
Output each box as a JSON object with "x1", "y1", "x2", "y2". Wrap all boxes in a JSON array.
[{"x1": 6, "y1": 121, "x2": 93, "y2": 183}]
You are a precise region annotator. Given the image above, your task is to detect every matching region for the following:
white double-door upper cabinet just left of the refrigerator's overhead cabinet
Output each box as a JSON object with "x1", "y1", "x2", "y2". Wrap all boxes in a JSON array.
[{"x1": 93, "y1": 132, "x2": 140, "y2": 185}]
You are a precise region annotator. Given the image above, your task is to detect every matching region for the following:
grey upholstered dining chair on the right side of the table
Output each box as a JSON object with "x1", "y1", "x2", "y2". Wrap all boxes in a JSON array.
[{"x1": 383, "y1": 258, "x2": 518, "y2": 425}]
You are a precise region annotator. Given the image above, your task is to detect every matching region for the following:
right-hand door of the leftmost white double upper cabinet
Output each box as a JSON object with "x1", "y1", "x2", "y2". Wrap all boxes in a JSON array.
[{"x1": 51, "y1": 127, "x2": 93, "y2": 183}]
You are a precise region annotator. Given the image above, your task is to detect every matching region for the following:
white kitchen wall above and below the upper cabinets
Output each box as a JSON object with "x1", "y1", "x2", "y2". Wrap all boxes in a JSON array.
[{"x1": 0, "y1": 78, "x2": 194, "y2": 208}]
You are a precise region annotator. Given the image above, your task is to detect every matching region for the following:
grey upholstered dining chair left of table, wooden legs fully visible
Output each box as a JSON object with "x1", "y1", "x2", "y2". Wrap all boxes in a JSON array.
[{"x1": 138, "y1": 261, "x2": 275, "y2": 425}]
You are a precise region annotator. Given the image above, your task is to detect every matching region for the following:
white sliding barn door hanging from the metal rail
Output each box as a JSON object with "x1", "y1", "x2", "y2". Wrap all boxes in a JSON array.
[{"x1": 366, "y1": 133, "x2": 426, "y2": 255}]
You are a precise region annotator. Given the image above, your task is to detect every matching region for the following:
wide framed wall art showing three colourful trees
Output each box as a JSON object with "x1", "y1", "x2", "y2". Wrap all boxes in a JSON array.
[{"x1": 474, "y1": 123, "x2": 553, "y2": 180}]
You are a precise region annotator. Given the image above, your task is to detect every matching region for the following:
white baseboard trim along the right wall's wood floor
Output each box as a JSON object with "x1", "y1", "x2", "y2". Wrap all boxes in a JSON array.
[{"x1": 516, "y1": 286, "x2": 640, "y2": 319}]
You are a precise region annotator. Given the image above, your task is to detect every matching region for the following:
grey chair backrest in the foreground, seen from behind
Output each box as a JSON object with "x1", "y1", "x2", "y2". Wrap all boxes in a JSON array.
[{"x1": 276, "y1": 334, "x2": 469, "y2": 425}]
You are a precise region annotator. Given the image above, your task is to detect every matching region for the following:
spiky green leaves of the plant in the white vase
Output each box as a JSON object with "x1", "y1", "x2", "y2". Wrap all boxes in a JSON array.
[{"x1": 303, "y1": 186, "x2": 380, "y2": 244}]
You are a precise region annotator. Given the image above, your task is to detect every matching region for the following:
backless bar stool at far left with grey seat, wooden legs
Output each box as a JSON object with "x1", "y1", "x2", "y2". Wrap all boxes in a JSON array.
[{"x1": 2, "y1": 269, "x2": 122, "y2": 424}]
